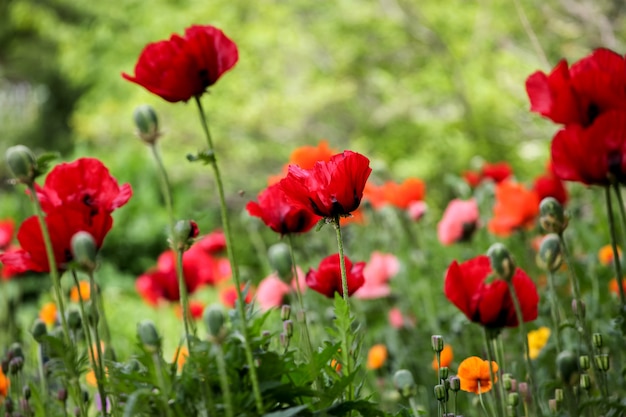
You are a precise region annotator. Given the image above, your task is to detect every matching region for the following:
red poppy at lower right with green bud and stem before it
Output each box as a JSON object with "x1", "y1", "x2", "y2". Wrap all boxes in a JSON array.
[{"x1": 444, "y1": 255, "x2": 539, "y2": 328}]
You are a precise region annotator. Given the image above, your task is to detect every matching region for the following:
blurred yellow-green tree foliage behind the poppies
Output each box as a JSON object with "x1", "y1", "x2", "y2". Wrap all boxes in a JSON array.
[{"x1": 0, "y1": 0, "x2": 626, "y2": 269}]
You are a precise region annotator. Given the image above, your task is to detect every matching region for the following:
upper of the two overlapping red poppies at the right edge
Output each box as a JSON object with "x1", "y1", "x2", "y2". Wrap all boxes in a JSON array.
[{"x1": 526, "y1": 48, "x2": 626, "y2": 126}]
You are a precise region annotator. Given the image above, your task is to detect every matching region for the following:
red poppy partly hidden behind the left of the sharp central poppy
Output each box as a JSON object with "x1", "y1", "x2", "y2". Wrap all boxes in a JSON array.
[{"x1": 246, "y1": 184, "x2": 320, "y2": 235}]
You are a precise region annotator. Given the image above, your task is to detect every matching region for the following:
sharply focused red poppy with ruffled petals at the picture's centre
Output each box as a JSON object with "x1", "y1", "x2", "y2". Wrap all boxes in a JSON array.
[{"x1": 279, "y1": 151, "x2": 372, "y2": 218}]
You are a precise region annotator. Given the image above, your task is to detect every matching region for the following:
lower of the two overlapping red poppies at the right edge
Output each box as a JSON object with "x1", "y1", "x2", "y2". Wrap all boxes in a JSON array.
[{"x1": 551, "y1": 111, "x2": 626, "y2": 185}]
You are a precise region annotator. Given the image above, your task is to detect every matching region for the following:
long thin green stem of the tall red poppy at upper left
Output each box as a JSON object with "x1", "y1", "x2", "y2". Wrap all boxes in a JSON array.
[{"x1": 195, "y1": 96, "x2": 264, "y2": 415}]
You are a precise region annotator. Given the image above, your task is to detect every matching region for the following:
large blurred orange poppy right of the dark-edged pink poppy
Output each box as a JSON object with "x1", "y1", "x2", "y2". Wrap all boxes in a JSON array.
[{"x1": 488, "y1": 181, "x2": 539, "y2": 236}]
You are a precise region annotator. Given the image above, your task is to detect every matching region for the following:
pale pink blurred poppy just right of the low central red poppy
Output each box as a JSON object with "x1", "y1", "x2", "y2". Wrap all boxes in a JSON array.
[{"x1": 354, "y1": 252, "x2": 400, "y2": 299}]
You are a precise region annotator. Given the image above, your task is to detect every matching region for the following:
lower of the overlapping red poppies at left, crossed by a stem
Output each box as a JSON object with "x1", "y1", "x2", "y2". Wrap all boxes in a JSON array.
[{"x1": 0, "y1": 206, "x2": 113, "y2": 273}]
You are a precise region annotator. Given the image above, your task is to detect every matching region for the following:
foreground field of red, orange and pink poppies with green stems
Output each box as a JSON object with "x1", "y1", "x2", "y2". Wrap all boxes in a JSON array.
[{"x1": 0, "y1": 15, "x2": 626, "y2": 417}]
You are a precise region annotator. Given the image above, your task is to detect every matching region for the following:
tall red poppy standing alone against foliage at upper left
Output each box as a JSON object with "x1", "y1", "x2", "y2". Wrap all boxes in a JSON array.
[{"x1": 122, "y1": 26, "x2": 239, "y2": 103}]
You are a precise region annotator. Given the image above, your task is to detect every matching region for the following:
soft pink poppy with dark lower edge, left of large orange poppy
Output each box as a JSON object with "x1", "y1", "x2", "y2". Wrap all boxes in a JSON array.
[{"x1": 437, "y1": 198, "x2": 480, "y2": 245}]
